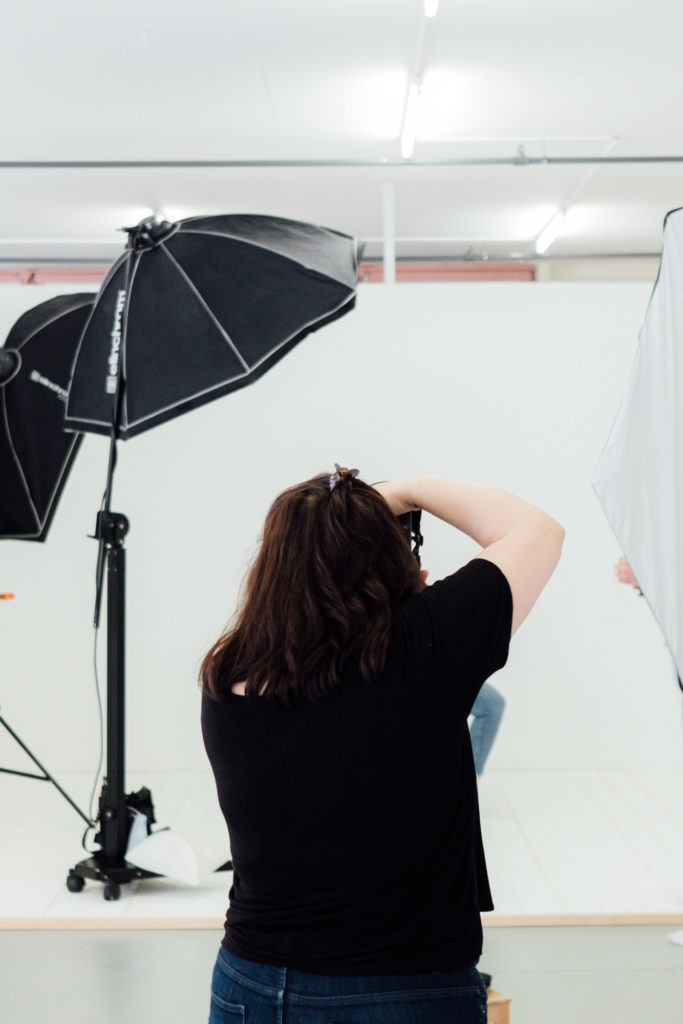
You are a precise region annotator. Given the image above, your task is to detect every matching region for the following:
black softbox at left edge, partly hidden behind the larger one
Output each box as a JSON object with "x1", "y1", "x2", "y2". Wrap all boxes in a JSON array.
[{"x1": 0, "y1": 294, "x2": 94, "y2": 541}]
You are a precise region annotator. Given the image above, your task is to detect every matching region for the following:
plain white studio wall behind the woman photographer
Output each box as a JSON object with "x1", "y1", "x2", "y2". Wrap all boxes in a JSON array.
[{"x1": 0, "y1": 283, "x2": 681, "y2": 772}]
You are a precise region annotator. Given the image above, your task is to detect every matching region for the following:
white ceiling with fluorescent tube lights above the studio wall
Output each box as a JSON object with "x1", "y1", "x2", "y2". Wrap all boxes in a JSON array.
[{"x1": 0, "y1": 0, "x2": 683, "y2": 264}]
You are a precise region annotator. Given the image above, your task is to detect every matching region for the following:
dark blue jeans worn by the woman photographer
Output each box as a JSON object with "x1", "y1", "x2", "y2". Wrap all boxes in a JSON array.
[{"x1": 209, "y1": 947, "x2": 486, "y2": 1024}]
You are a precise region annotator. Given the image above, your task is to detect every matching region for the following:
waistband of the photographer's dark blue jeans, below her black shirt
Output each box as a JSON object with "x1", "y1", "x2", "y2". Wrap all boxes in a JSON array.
[{"x1": 217, "y1": 946, "x2": 480, "y2": 996}]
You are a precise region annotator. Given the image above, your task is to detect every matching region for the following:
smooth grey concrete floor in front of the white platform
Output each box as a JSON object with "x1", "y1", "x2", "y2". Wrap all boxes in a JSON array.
[{"x1": 0, "y1": 927, "x2": 683, "y2": 1024}]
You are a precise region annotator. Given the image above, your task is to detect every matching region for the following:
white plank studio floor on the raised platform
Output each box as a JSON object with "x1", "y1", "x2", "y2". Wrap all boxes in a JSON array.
[{"x1": 0, "y1": 765, "x2": 683, "y2": 929}]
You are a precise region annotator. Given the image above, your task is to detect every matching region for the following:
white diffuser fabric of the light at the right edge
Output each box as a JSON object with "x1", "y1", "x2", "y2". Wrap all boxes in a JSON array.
[{"x1": 593, "y1": 209, "x2": 683, "y2": 677}]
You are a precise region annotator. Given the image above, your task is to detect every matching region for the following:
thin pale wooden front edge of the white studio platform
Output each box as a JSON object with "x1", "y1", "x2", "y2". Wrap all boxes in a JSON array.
[{"x1": 0, "y1": 910, "x2": 683, "y2": 935}]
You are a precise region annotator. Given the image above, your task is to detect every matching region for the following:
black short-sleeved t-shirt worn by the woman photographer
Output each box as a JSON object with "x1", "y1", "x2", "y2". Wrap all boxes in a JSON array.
[{"x1": 202, "y1": 558, "x2": 512, "y2": 975}]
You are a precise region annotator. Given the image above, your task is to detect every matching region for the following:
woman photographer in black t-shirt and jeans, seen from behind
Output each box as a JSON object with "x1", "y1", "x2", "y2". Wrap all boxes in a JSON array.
[{"x1": 201, "y1": 467, "x2": 563, "y2": 1024}]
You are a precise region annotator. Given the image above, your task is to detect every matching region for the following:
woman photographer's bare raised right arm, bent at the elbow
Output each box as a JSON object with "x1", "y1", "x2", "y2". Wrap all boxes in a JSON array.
[{"x1": 375, "y1": 476, "x2": 564, "y2": 633}]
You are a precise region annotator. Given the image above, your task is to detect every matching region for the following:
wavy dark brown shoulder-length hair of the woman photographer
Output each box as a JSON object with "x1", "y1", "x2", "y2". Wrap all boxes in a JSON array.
[{"x1": 200, "y1": 471, "x2": 422, "y2": 705}]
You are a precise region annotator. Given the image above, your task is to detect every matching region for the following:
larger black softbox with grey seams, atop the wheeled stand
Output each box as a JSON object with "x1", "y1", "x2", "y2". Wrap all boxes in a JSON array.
[{"x1": 66, "y1": 214, "x2": 357, "y2": 439}]
